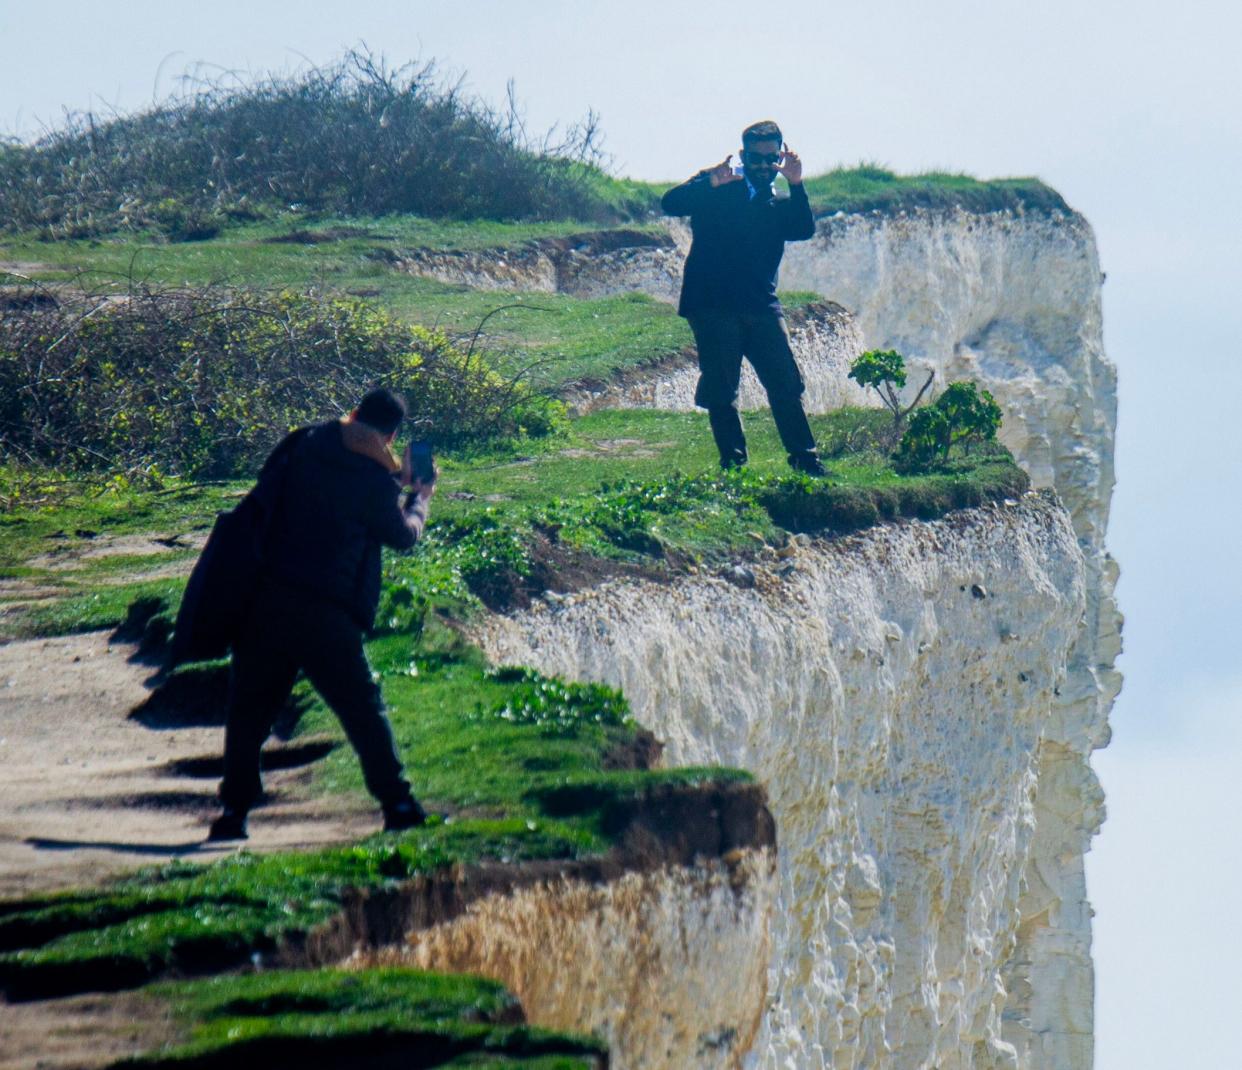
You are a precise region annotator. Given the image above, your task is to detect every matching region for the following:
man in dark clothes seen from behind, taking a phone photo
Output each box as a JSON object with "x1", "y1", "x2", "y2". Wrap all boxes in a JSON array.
[{"x1": 209, "y1": 390, "x2": 435, "y2": 840}]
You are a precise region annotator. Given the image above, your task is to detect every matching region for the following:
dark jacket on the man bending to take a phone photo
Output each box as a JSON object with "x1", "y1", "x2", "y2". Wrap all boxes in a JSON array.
[{"x1": 260, "y1": 420, "x2": 426, "y2": 629}]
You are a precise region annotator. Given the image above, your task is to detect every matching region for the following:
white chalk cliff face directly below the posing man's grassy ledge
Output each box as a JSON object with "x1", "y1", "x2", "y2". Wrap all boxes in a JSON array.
[{"x1": 479, "y1": 495, "x2": 1086, "y2": 1070}]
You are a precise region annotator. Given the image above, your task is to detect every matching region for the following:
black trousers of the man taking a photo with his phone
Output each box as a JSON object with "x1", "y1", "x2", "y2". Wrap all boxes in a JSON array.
[{"x1": 220, "y1": 586, "x2": 410, "y2": 813}]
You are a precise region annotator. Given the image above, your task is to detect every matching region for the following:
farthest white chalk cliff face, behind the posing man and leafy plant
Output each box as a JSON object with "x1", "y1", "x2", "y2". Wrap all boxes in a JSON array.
[{"x1": 576, "y1": 204, "x2": 1122, "y2": 1068}]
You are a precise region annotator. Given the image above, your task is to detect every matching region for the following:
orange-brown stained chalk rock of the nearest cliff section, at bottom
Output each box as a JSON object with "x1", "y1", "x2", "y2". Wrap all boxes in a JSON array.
[{"x1": 347, "y1": 849, "x2": 776, "y2": 1070}]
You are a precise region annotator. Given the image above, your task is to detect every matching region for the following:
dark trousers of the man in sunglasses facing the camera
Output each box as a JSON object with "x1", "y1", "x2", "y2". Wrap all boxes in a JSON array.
[{"x1": 688, "y1": 310, "x2": 817, "y2": 468}]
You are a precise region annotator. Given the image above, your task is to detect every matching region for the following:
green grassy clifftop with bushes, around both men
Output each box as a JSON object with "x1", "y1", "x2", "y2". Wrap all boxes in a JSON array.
[{"x1": 0, "y1": 56, "x2": 1043, "y2": 1070}]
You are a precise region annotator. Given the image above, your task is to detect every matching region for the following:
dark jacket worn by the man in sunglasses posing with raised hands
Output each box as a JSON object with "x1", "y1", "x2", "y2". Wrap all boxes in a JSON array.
[{"x1": 661, "y1": 171, "x2": 815, "y2": 317}]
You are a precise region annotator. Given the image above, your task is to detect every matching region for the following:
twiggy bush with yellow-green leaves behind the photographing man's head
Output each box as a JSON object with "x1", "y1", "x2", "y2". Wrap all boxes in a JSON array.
[{"x1": 0, "y1": 285, "x2": 559, "y2": 479}]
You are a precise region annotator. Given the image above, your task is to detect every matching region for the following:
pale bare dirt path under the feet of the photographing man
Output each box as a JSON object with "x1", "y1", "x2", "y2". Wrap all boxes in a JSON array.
[{"x1": 0, "y1": 632, "x2": 379, "y2": 899}]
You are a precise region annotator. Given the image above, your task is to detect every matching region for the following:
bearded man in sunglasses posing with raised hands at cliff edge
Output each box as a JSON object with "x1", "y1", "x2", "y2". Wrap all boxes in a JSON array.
[{"x1": 661, "y1": 120, "x2": 827, "y2": 475}]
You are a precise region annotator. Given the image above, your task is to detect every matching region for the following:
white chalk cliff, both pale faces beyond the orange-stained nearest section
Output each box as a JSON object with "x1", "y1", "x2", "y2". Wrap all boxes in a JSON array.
[{"x1": 447, "y1": 204, "x2": 1120, "y2": 1070}]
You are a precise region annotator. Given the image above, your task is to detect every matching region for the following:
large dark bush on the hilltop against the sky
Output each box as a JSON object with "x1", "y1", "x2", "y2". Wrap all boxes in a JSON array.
[{"x1": 0, "y1": 51, "x2": 651, "y2": 241}]
